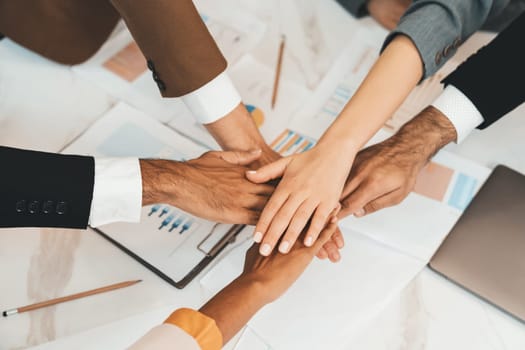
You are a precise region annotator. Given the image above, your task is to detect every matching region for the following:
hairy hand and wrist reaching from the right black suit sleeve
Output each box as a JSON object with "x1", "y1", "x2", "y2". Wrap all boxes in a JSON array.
[{"x1": 339, "y1": 106, "x2": 457, "y2": 218}]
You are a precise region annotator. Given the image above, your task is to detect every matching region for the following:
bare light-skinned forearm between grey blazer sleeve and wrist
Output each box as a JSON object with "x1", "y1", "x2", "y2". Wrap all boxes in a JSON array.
[{"x1": 319, "y1": 35, "x2": 423, "y2": 152}]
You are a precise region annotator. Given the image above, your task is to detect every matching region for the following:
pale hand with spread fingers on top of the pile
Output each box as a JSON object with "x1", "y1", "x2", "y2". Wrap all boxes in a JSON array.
[{"x1": 246, "y1": 143, "x2": 353, "y2": 255}]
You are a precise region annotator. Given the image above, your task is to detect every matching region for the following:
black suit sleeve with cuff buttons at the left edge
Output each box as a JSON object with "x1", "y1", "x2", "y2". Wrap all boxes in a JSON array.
[{"x1": 0, "y1": 147, "x2": 95, "y2": 228}]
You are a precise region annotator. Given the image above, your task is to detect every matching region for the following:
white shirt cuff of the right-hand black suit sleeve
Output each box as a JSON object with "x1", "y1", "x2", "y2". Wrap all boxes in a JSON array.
[{"x1": 432, "y1": 85, "x2": 483, "y2": 143}]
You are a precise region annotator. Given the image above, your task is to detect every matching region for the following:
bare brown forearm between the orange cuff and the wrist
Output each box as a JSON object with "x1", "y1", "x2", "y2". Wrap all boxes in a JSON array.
[{"x1": 199, "y1": 275, "x2": 267, "y2": 344}]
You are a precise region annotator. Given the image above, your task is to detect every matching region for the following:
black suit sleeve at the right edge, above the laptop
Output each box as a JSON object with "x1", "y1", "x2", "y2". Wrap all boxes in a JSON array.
[{"x1": 443, "y1": 14, "x2": 525, "y2": 129}]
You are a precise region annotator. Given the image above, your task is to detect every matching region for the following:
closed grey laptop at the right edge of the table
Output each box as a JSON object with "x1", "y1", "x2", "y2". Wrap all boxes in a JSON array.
[{"x1": 429, "y1": 165, "x2": 525, "y2": 322}]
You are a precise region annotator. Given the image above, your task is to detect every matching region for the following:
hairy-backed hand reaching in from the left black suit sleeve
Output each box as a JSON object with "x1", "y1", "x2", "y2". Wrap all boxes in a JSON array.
[{"x1": 140, "y1": 150, "x2": 274, "y2": 225}]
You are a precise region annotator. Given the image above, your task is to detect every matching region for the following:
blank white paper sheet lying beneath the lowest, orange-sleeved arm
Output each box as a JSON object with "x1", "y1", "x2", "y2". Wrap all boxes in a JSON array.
[{"x1": 201, "y1": 228, "x2": 424, "y2": 350}]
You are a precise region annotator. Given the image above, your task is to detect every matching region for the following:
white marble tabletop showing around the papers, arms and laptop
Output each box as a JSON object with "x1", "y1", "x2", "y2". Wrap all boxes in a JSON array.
[{"x1": 0, "y1": 0, "x2": 525, "y2": 349}]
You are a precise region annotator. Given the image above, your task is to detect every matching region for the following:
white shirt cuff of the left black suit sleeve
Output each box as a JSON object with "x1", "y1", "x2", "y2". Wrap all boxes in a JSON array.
[{"x1": 89, "y1": 158, "x2": 142, "y2": 227}]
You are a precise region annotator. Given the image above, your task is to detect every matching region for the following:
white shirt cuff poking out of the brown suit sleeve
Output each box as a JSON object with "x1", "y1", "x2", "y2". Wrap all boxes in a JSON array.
[{"x1": 181, "y1": 72, "x2": 241, "y2": 124}]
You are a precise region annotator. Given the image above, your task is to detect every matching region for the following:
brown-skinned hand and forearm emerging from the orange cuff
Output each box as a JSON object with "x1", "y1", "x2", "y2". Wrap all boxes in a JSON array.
[{"x1": 199, "y1": 217, "x2": 337, "y2": 344}]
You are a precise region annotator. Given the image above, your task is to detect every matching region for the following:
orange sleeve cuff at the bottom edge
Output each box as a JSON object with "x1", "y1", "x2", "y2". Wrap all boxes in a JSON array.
[{"x1": 164, "y1": 309, "x2": 222, "y2": 350}]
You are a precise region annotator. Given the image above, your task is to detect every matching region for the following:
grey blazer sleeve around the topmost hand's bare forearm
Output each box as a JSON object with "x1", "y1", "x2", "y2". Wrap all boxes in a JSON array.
[{"x1": 383, "y1": 0, "x2": 509, "y2": 79}]
